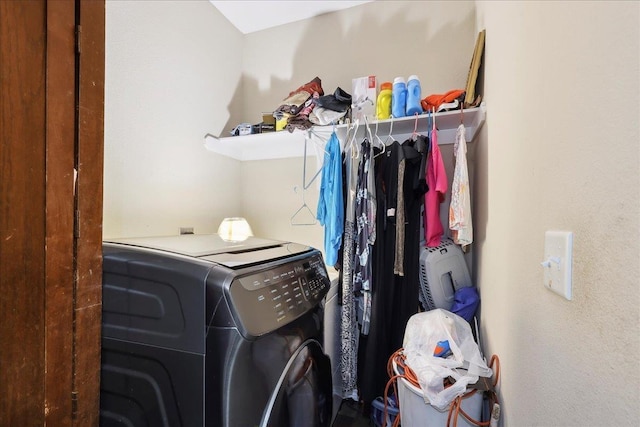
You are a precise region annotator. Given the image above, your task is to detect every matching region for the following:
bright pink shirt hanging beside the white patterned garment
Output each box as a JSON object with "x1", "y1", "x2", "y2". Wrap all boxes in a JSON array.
[{"x1": 424, "y1": 125, "x2": 449, "y2": 247}]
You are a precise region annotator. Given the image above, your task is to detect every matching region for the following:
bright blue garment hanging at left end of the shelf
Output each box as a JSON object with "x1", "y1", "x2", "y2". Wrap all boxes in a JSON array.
[{"x1": 316, "y1": 132, "x2": 344, "y2": 266}]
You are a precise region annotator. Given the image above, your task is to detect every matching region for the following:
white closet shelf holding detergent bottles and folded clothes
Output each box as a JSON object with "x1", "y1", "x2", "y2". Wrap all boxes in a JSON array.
[{"x1": 204, "y1": 102, "x2": 486, "y2": 161}]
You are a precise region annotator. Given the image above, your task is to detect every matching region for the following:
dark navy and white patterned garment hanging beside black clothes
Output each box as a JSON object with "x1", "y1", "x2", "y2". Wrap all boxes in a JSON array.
[{"x1": 353, "y1": 138, "x2": 376, "y2": 335}]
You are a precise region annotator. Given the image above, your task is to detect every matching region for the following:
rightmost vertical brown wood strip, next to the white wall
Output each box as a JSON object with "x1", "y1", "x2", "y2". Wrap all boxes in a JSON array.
[{"x1": 74, "y1": 0, "x2": 105, "y2": 426}]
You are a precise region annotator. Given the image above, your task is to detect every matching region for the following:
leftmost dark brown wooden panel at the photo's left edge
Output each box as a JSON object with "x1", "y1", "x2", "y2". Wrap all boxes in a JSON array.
[{"x1": 0, "y1": 1, "x2": 46, "y2": 426}]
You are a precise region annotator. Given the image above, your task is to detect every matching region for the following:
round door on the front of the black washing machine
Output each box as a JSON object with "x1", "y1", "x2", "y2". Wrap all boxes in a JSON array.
[{"x1": 260, "y1": 339, "x2": 332, "y2": 427}]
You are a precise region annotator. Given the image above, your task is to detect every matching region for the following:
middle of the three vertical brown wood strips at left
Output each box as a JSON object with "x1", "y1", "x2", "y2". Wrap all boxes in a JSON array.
[{"x1": 44, "y1": 0, "x2": 76, "y2": 426}]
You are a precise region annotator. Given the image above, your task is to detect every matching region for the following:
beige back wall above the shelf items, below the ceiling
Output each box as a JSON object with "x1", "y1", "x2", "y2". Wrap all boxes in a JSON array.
[{"x1": 243, "y1": 1, "x2": 476, "y2": 127}]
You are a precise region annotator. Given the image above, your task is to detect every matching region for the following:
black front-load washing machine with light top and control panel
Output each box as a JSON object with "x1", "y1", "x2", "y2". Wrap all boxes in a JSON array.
[{"x1": 100, "y1": 235, "x2": 332, "y2": 427}]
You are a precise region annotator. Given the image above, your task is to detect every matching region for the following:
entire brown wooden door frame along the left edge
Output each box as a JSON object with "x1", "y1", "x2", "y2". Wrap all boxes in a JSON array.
[{"x1": 0, "y1": 0, "x2": 105, "y2": 426}]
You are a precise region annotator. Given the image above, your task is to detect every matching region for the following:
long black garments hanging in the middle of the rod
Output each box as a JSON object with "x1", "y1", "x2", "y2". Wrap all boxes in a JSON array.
[{"x1": 358, "y1": 141, "x2": 426, "y2": 403}]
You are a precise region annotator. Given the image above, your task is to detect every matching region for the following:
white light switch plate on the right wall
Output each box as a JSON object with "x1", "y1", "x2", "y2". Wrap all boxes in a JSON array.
[{"x1": 542, "y1": 231, "x2": 573, "y2": 300}]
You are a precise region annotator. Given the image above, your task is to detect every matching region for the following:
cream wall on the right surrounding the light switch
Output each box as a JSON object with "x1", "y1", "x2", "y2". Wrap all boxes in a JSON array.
[{"x1": 474, "y1": 1, "x2": 640, "y2": 426}]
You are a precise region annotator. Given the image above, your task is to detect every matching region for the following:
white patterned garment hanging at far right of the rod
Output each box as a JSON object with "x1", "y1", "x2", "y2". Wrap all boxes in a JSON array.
[{"x1": 449, "y1": 124, "x2": 473, "y2": 246}]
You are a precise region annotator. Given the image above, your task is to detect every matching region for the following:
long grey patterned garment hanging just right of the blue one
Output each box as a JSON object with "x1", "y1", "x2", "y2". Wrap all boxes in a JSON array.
[{"x1": 340, "y1": 143, "x2": 359, "y2": 400}]
